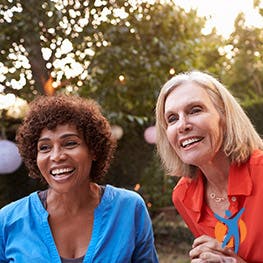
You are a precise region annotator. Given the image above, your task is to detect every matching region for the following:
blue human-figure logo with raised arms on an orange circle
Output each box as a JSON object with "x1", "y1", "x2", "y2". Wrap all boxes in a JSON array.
[{"x1": 214, "y1": 207, "x2": 247, "y2": 253}]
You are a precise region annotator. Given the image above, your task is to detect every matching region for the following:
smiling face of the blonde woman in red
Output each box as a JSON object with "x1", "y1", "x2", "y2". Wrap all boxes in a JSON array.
[{"x1": 164, "y1": 82, "x2": 223, "y2": 168}]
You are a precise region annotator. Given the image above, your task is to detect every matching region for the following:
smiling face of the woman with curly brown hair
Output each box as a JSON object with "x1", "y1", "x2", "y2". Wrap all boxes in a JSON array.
[{"x1": 37, "y1": 124, "x2": 94, "y2": 192}]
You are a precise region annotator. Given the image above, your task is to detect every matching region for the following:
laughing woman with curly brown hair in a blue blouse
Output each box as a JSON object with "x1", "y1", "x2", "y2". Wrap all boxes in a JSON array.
[{"x1": 0, "y1": 95, "x2": 158, "y2": 263}]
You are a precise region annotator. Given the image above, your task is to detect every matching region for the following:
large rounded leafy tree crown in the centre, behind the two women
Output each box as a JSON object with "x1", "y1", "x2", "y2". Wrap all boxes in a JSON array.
[{"x1": 79, "y1": 3, "x2": 224, "y2": 121}]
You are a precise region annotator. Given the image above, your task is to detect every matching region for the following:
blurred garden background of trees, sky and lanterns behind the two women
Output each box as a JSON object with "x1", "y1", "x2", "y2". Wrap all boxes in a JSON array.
[{"x1": 0, "y1": 0, "x2": 263, "y2": 263}]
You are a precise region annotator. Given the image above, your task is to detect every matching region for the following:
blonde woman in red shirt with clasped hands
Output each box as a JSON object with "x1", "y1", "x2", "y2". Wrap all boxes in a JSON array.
[{"x1": 156, "y1": 71, "x2": 263, "y2": 262}]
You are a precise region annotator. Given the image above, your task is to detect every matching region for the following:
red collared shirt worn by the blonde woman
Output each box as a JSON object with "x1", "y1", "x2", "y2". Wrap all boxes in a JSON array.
[{"x1": 173, "y1": 150, "x2": 263, "y2": 263}]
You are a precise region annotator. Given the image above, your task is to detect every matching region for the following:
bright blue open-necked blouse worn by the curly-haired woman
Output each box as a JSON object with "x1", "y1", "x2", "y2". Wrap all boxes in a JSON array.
[{"x1": 0, "y1": 185, "x2": 158, "y2": 263}]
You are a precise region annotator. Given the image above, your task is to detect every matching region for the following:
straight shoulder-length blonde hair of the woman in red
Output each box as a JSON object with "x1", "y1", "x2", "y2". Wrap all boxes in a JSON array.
[{"x1": 156, "y1": 71, "x2": 263, "y2": 177}]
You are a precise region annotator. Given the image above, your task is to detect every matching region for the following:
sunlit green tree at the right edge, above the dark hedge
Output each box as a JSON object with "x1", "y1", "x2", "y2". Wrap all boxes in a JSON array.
[{"x1": 223, "y1": 14, "x2": 263, "y2": 101}]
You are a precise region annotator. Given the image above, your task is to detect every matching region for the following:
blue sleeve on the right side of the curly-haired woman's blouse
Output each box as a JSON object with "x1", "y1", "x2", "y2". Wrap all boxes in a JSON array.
[{"x1": 132, "y1": 199, "x2": 159, "y2": 263}]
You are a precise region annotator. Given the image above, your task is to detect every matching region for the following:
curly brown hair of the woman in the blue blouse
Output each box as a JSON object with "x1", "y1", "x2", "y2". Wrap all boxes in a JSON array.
[{"x1": 16, "y1": 95, "x2": 116, "y2": 184}]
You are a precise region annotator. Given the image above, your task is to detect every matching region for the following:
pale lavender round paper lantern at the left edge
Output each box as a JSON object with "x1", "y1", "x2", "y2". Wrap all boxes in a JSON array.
[{"x1": 0, "y1": 140, "x2": 22, "y2": 174}]
